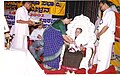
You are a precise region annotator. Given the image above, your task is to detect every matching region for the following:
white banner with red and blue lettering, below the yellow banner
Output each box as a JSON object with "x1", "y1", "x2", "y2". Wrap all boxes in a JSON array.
[{"x1": 5, "y1": 10, "x2": 58, "y2": 27}]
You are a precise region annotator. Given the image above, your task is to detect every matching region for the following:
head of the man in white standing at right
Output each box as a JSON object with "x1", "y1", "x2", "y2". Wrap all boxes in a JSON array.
[{"x1": 99, "y1": 0, "x2": 113, "y2": 11}]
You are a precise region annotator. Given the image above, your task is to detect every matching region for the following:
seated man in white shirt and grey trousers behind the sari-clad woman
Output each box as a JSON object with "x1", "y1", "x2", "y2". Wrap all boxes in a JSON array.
[{"x1": 29, "y1": 23, "x2": 45, "y2": 62}]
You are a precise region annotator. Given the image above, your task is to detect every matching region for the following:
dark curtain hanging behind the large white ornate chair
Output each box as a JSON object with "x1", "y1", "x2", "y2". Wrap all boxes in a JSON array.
[{"x1": 66, "y1": 1, "x2": 99, "y2": 23}]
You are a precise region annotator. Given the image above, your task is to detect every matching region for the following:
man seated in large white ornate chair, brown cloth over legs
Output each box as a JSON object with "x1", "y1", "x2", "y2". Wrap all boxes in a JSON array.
[{"x1": 62, "y1": 28, "x2": 85, "y2": 71}]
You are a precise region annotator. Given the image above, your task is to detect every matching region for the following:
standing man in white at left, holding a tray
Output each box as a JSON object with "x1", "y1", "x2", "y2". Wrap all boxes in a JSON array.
[{"x1": 12, "y1": 1, "x2": 33, "y2": 49}]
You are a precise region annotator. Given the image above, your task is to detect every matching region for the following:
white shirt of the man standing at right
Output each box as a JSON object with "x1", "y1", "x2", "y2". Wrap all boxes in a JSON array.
[{"x1": 99, "y1": 8, "x2": 116, "y2": 42}]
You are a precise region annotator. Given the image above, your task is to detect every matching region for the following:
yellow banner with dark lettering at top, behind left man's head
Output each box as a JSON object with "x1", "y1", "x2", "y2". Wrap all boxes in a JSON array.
[{"x1": 4, "y1": 1, "x2": 66, "y2": 16}]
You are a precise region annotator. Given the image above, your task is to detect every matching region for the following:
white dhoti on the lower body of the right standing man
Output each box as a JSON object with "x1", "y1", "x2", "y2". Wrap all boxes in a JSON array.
[{"x1": 94, "y1": 41, "x2": 113, "y2": 73}]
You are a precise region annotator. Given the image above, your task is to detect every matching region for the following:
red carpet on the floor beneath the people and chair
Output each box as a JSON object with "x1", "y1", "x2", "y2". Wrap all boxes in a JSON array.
[{"x1": 38, "y1": 58, "x2": 116, "y2": 74}]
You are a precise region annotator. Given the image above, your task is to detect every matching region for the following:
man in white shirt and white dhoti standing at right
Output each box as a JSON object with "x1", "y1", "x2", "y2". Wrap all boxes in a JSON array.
[{"x1": 94, "y1": 1, "x2": 115, "y2": 73}]
